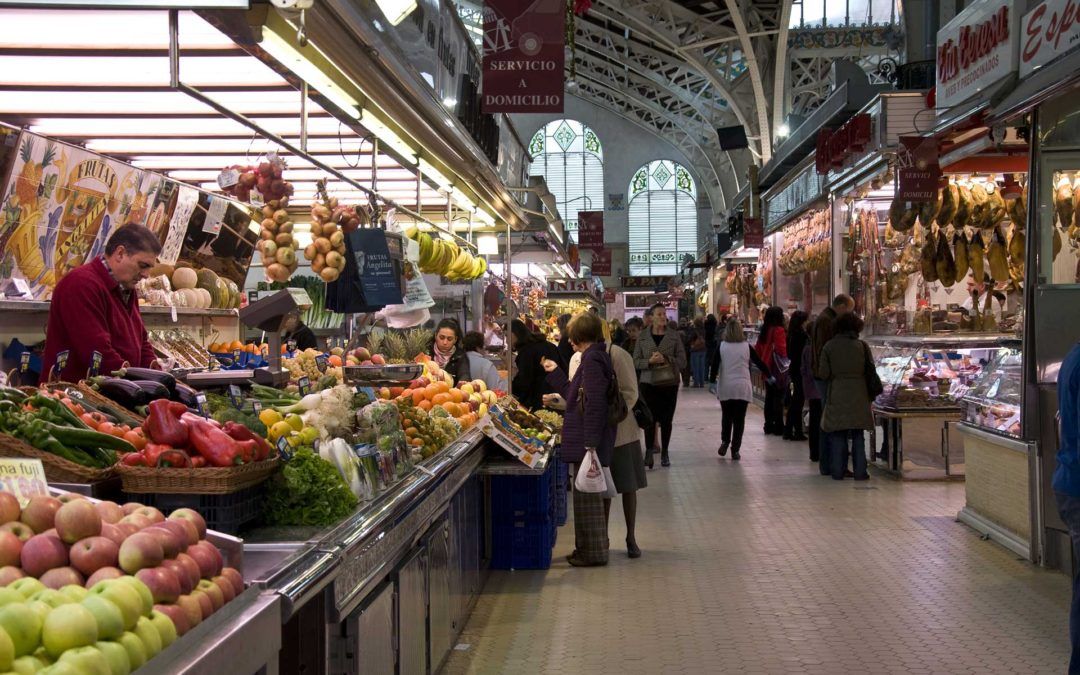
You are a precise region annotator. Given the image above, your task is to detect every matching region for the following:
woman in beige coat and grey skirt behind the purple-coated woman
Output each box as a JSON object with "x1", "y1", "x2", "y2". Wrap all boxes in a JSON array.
[{"x1": 544, "y1": 323, "x2": 648, "y2": 558}]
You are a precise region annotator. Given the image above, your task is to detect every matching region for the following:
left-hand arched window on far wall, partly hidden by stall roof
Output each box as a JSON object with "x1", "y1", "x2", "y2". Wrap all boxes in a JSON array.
[{"x1": 529, "y1": 120, "x2": 604, "y2": 242}]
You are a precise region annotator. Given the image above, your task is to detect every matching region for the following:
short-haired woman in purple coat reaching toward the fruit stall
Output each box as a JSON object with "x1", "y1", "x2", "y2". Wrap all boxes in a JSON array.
[{"x1": 543, "y1": 312, "x2": 616, "y2": 567}]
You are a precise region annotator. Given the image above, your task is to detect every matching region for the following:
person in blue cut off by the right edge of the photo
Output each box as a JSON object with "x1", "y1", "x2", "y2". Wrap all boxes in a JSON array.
[{"x1": 1053, "y1": 342, "x2": 1080, "y2": 674}]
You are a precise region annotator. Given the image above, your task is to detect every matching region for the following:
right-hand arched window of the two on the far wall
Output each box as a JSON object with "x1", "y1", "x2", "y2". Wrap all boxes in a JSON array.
[{"x1": 629, "y1": 160, "x2": 698, "y2": 275}]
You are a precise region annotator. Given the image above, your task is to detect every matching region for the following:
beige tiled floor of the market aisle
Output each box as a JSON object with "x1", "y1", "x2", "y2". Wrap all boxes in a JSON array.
[{"x1": 445, "y1": 389, "x2": 1069, "y2": 675}]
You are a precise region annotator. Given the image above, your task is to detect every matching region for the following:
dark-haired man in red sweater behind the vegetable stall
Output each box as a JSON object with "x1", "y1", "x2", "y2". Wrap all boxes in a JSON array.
[{"x1": 42, "y1": 224, "x2": 161, "y2": 382}]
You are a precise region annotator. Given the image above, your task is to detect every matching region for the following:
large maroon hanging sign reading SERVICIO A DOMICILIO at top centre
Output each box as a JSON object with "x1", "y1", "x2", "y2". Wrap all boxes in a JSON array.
[{"x1": 481, "y1": 0, "x2": 566, "y2": 112}]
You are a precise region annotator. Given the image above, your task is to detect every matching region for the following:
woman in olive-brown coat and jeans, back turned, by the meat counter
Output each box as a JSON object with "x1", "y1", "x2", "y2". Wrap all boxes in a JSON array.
[{"x1": 818, "y1": 312, "x2": 874, "y2": 481}]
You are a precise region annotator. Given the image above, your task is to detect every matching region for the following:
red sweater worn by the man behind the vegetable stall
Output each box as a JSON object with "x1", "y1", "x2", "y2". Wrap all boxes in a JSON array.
[{"x1": 41, "y1": 258, "x2": 156, "y2": 382}]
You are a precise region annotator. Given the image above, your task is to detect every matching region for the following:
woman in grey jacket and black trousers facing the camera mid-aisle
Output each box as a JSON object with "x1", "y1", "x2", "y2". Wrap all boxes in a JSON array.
[{"x1": 634, "y1": 302, "x2": 687, "y2": 469}]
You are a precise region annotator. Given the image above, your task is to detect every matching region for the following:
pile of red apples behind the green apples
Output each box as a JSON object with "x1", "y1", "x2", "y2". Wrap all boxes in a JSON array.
[{"x1": 0, "y1": 492, "x2": 244, "y2": 652}]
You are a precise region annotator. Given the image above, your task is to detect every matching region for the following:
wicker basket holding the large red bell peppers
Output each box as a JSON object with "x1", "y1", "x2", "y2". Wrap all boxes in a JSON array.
[{"x1": 117, "y1": 457, "x2": 278, "y2": 495}]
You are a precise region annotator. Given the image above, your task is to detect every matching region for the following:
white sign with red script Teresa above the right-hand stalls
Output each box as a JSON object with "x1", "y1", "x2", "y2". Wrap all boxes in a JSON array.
[{"x1": 937, "y1": 0, "x2": 1020, "y2": 108}]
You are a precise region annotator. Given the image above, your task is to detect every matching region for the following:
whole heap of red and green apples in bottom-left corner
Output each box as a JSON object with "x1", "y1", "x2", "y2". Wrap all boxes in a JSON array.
[{"x1": 0, "y1": 492, "x2": 244, "y2": 674}]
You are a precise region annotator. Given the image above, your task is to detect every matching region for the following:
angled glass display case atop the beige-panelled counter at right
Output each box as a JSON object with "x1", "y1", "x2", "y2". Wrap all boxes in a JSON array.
[{"x1": 963, "y1": 347, "x2": 1024, "y2": 437}]
